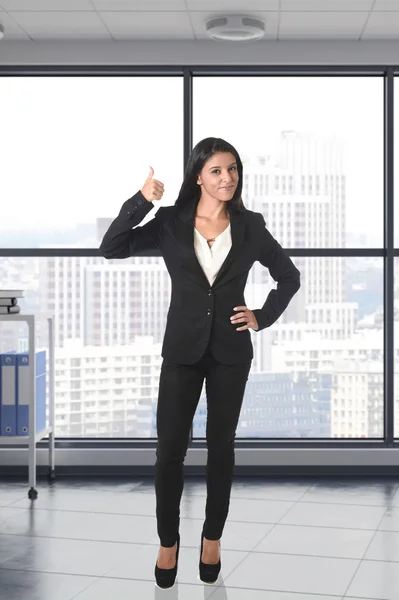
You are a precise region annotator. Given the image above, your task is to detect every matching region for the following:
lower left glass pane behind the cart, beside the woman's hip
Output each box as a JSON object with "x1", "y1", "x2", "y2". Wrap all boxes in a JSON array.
[{"x1": 0, "y1": 257, "x2": 171, "y2": 438}]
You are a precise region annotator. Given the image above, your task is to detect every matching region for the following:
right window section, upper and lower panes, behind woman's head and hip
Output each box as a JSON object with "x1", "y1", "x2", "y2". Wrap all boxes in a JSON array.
[{"x1": 193, "y1": 76, "x2": 384, "y2": 438}]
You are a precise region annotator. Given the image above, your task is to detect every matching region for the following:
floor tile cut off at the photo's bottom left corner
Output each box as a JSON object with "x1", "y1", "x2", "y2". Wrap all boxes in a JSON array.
[{"x1": 0, "y1": 570, "x2": 95, "y2": 600}]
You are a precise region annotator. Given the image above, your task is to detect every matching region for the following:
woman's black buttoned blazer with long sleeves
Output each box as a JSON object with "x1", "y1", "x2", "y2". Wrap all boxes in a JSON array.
[{"x1": 100, "y1": 192, "x2": 300, "y2": 364}]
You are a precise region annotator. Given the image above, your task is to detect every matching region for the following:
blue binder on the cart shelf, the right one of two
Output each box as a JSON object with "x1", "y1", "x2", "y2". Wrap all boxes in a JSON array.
[{"x1": 16, "y1": 350, "x2": 46, "y2": 436}]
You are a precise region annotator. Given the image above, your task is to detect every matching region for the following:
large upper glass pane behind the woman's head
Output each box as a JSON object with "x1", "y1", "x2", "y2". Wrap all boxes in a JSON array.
[{"x1": 194, "y1": 77, "x2": 384, "y2": 248}]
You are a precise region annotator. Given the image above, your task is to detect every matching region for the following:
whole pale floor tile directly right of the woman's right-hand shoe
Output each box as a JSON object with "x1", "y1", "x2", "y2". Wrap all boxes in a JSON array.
[{"x1": 225, "y1": 552, "x2": 359, "y2": 596}]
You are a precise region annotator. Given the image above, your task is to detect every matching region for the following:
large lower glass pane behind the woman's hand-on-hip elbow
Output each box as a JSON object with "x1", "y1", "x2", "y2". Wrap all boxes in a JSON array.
[{"x1": 193, "y1": 257, "x2": 384, "y2": 438}]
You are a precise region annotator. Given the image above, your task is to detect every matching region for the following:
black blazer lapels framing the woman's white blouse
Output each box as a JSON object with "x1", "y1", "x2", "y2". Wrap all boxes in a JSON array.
[{"x1": 176, "y1": 198, "x2": 245, "y2": 289}]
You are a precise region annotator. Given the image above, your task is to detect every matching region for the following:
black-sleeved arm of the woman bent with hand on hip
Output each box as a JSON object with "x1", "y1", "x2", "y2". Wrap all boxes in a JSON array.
[{"x1": 252, "y1": 215, "x2": 301, "y2": 331}]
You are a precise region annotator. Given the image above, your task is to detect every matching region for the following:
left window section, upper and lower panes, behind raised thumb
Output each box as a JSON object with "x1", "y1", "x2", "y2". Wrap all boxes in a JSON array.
[{"x1": 0, "y1": 76, "x2": 183, "y2": 438}]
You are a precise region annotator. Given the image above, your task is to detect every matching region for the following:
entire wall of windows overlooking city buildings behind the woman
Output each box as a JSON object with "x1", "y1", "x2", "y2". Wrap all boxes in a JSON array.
[{"x1": 0, "y1": 76, "x2": 390, "y2": 439}]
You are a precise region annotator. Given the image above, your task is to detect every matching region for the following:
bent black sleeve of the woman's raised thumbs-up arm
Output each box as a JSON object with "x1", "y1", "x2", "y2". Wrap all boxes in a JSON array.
[{"x1": 99, "y1": 192, "x2": 162, "y2": 258}]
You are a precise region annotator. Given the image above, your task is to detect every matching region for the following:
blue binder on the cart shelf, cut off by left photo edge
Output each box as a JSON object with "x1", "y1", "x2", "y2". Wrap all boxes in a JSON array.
[{"x1": 0, "y1": 352, "x2": 17, "y2": 436}]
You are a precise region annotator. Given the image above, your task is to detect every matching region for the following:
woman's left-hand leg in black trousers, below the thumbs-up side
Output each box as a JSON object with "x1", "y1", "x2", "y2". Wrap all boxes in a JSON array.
[{"x1": 155, "y1": 361, "x2": 204, "y2": 548}]
